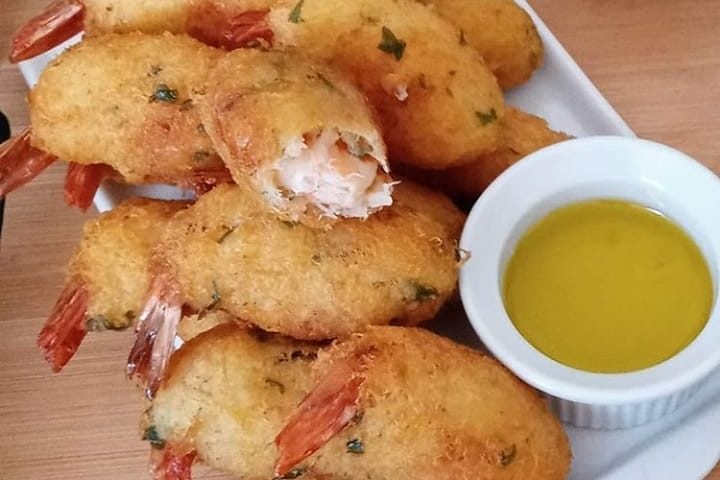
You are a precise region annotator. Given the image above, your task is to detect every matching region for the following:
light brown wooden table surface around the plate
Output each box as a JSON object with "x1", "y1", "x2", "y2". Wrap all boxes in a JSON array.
[{"x1": 0, "y1": 0, "x2": 720, "y2": 480}]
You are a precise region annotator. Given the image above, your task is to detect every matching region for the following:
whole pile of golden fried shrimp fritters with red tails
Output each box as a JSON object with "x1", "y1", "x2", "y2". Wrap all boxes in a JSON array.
[{"x1": 0, "y1": 0, "x2": 570, "y2": 480}]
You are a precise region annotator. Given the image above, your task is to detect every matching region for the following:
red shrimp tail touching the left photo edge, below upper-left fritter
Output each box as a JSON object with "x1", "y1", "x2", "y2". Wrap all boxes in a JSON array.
[{"x1": 0, "y1": 127, "x2": 57, "y2": 197}]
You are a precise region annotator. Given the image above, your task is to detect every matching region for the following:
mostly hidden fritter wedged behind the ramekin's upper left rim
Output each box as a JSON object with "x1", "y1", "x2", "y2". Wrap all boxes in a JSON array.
[{"x1": 400, "y1": 108, "x2": 571, "y2": 200}]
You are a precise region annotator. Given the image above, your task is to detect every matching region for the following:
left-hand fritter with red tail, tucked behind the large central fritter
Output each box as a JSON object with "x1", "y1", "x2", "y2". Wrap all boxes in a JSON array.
[{"x1": 38, "y1": 198, "x2": 186, "y2": 371}]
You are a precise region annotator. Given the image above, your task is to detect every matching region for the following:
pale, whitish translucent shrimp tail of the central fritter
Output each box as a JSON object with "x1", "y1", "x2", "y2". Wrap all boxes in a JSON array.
[{"x1": 126, "y1": 274, "x2": 182, "y2": 399}]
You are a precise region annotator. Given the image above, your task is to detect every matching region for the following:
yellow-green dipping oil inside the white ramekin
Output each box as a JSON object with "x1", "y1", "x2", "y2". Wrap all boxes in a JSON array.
[{"x1": 503, "y1": 200, "x2": 713, "y2": 373}]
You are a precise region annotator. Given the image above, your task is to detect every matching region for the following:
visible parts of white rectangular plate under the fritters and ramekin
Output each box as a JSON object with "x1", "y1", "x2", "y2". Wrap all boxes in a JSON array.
[{"x1": 15, "y1": 0, "x2": 720, "y2": 480}]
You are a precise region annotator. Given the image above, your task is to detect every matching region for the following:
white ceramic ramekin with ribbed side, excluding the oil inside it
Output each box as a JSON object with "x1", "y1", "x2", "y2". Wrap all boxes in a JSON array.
[{"x1": 460, "y1": 137, "x2": 720, "y2": 429}]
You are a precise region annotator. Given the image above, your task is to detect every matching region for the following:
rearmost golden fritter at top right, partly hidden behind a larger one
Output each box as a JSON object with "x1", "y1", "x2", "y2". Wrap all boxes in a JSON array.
[{"x1": 418, "y1": 0, "x2": 544, "y2": 89}]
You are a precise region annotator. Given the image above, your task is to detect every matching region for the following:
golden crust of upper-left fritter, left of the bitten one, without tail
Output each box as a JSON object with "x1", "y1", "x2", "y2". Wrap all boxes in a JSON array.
[{"x1": 29, "y1": 33, "x2": 222, "y2": 183}]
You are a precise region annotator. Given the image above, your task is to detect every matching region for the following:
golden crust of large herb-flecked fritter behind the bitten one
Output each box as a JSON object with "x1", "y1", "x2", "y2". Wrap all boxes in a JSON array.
[{"x1": 269, "y1": 0, "x2": 504, "y2": 169}]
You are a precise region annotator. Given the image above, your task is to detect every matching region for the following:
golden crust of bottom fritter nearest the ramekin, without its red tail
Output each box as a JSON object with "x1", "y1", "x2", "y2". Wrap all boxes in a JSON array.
[{"x1": 310, "y1": 327, "x2": 571, "y2": 480}]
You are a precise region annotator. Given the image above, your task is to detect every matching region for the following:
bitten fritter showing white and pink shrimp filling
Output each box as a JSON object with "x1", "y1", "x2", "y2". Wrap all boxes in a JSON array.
[{"x1": 194, "y1": 49, "x2": 392, "y2": 221}]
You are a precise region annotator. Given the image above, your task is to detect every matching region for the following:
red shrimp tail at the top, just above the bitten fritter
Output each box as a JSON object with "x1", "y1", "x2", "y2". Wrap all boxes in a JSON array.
[{"x1": 186, "y1": 7, "x2": 273, "y2": 50}]
